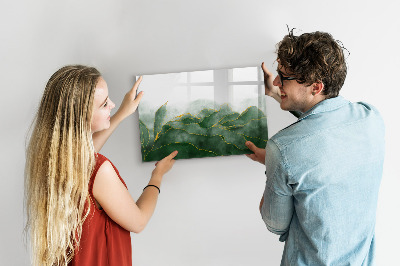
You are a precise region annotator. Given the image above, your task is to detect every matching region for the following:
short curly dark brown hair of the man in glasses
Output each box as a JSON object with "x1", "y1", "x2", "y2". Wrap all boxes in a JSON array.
[{"x1": 277, "y1": 29, "x2": 347, "y2": 98}]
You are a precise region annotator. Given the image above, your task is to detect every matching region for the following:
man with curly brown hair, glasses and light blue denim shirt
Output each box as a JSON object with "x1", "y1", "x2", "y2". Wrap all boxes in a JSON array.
[{"x1": 246, "y1": 31, "x2": 384, "y2": 266}]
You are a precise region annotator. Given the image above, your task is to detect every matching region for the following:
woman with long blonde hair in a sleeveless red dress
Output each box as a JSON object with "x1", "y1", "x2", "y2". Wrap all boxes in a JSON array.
[{"x1": 25, "y1": 65, "x2": 177, "y2": 265}]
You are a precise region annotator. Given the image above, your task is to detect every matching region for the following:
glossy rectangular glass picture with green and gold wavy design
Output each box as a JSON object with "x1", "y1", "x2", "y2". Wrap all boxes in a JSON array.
[{"x1": 139, "y1": 67, "x2": 268, "y2": 162}]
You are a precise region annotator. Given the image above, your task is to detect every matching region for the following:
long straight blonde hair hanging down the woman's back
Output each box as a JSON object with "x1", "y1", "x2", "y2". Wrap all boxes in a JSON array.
[{"x1": 25, "y1": 65, "x2": 101, "y2": 265}]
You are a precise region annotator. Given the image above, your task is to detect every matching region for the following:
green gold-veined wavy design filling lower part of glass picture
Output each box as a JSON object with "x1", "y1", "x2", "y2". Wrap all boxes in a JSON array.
[{"x1": 139, "y1": 103, "x2": 268, "y2": 161}]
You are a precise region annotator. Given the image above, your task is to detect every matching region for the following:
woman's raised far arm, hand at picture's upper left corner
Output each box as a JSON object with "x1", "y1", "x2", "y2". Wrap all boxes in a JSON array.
[{"x1": 92, "y1": 77, "x2": 143, "y2": 152}]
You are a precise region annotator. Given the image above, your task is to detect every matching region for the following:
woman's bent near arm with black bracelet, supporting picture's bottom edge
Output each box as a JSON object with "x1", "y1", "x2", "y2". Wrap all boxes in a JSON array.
[{"x1": 93, "y1": 151, "x2": 178, "y2": 233}]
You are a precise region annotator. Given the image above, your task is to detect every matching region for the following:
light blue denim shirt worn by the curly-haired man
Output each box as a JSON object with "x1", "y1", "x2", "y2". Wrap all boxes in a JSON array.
[{"x1": 261, "y1": 96, "x2": 385, "y2": 266}]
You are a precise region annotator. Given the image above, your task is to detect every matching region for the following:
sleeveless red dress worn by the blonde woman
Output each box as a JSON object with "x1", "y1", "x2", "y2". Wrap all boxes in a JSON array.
[{"x1": 69, "y1": 153, "x2": 132, "y2": 266}]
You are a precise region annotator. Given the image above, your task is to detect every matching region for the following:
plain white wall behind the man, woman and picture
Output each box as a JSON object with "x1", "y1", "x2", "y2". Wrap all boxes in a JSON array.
[{"x1": 0, "y1": 0, "x2": 400, "y2": 266}]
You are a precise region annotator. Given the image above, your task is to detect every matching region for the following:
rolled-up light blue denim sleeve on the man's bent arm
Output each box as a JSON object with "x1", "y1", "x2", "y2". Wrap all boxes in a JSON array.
[{"x1": 261, "y1": 140, "x2": 294, "y2": 241}]
